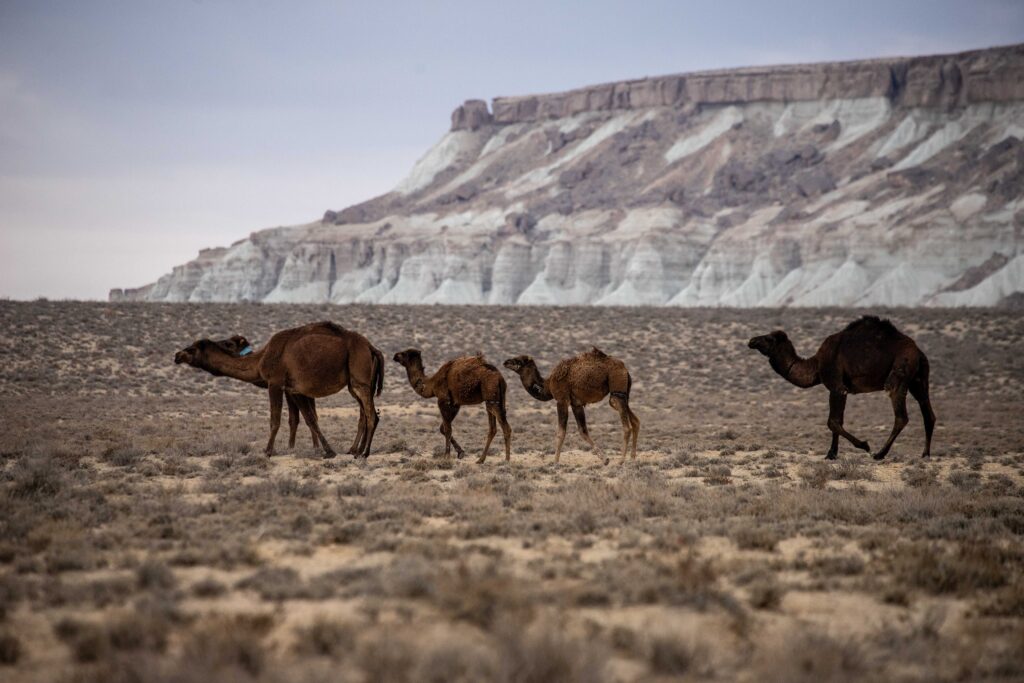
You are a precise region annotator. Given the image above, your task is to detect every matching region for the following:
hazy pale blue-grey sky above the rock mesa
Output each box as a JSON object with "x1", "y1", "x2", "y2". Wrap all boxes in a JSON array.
[{"x1": 0, "y1": 0, "x2": 1024, "y2": 298}]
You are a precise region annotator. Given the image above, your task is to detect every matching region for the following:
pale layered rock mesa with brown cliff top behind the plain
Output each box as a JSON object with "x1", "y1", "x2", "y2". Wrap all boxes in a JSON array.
[{"x1": 111, "y1": 46, "x2": 1024, "y2": 306}]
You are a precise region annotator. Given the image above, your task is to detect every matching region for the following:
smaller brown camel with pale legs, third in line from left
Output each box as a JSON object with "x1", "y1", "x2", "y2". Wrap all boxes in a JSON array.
[{"x1": 504, "y1": 346, "x2": 640, "y2": 465}]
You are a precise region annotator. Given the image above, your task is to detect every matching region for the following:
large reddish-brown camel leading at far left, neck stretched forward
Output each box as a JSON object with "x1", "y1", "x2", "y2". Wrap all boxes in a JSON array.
[{"x1": 174, "y1": 322, "x2": 384, "y2": 458}]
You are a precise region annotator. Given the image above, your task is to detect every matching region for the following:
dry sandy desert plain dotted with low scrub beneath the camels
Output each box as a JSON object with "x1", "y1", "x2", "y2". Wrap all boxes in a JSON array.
[{"x1": 0, "y1": 302, "x2": 1024, "y2": 681}]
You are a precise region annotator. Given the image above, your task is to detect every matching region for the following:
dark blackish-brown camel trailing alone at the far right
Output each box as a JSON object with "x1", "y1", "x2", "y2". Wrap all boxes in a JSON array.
[{"x1": 748, "y1": 315, "x2": 935, "y2": 460}]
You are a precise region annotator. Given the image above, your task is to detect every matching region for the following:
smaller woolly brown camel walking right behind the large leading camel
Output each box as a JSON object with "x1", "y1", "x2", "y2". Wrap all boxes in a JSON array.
[{"x1": 394, "y1": 348, "x2": 512, "y2": 464}]
